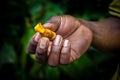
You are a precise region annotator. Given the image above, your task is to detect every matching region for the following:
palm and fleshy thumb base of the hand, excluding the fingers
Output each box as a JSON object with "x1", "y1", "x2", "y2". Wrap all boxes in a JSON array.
[{"x1": 53, "y1": 16, "x2": 92, "y2": 62}]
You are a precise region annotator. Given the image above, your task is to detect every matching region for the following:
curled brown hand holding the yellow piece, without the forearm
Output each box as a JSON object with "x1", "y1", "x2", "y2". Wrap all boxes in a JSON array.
[{"x1": 28, "y1": 15, "x2": 92, "y2": 66}]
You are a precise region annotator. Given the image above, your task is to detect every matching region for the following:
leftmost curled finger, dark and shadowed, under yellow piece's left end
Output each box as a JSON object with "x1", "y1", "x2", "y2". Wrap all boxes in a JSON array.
[{"x1": 28, "y1": 32, "x2": 41, "y2": 53}]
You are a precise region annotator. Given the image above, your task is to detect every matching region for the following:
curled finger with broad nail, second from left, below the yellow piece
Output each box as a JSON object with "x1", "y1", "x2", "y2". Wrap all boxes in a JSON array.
[{"x1": 36, "y1": 37, "x2": 49, "y2": 63}]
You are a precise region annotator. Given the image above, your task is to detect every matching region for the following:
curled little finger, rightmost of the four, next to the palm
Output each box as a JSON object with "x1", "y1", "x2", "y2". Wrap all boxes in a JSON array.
[{"x1": 60, "y1": 40, "x2": 70, "y2": 64}]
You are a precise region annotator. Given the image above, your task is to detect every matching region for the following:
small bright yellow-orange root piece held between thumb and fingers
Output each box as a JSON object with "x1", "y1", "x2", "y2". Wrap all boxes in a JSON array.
[{"x1": 34, "y1": 23, "x2": 56, "y2": 40}]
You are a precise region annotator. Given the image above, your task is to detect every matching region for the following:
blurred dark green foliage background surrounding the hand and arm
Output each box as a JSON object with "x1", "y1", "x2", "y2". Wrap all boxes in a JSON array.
[{"x1": 0, "y1": 0, "x2": 119, "y2": 80}]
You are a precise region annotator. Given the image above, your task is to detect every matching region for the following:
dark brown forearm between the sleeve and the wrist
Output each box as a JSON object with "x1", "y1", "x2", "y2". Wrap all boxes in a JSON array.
[{"x1": 80, "y1": 17, "x2": 120, "y2": 53}]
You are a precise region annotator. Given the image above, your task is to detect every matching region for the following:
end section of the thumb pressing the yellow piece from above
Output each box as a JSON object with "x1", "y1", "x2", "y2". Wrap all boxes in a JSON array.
[{"x1": 43, "y1": 16, "x2": 61, "y2": 31}]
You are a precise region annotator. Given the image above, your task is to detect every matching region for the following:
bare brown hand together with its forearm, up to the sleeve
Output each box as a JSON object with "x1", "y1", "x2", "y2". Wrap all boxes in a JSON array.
[{"x1": 28, "y1": 15, "x2": 120, "y2": 66}]
